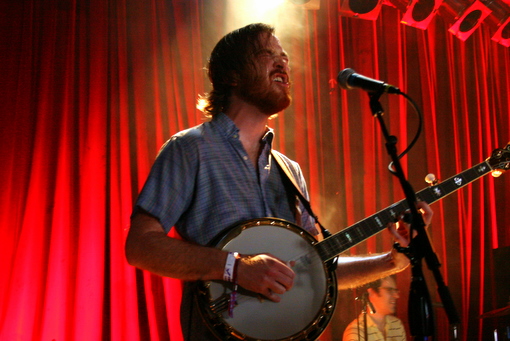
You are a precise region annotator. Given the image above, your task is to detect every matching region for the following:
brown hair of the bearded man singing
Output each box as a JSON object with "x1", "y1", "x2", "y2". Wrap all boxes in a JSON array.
[{"x1": 199, "y1": 23, "x2": 274, "y2": 116}]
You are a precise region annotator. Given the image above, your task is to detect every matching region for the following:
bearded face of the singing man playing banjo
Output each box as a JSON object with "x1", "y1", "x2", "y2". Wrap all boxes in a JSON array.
[{"x1": 234, "y1": 35, "x2": 291, "y2": 115}]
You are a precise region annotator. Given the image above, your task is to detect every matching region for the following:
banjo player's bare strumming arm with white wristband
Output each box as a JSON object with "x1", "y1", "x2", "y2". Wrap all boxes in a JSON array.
[{"x1": 125, "y1": 212, "x2": 295, "y2": 302}]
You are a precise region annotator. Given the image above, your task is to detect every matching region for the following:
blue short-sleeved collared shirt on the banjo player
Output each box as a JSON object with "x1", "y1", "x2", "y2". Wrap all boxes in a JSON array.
[{"x1": 136, "y1": 114, "x2": 317, "y2": 245}]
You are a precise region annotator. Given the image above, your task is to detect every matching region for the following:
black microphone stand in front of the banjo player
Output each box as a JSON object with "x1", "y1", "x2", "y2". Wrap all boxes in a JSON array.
[{"x1": 369, "y1": 89, "x2": 460, "y2": 341}]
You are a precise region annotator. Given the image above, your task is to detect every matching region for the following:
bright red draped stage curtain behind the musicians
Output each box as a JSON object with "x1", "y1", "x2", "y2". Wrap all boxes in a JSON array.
[{"x1": 0, "y1": 0, "x2": 510, "y2": 341}]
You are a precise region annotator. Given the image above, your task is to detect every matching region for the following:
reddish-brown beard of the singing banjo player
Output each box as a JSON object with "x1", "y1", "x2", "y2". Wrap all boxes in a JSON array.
[{"x1": 237, "y1": 72, "x2": 291, "y2": 115}]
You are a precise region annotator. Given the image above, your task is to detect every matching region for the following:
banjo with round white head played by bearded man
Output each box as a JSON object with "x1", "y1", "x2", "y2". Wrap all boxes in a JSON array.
[{"x1": 195, "y1": 144, "x2": 510, "y2": 341}]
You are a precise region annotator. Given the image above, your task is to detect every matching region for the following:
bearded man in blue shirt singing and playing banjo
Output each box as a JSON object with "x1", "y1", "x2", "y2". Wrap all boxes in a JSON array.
[{"x1": 126, "y1": 24, "x2": 432, "y2": 340}]
